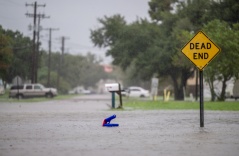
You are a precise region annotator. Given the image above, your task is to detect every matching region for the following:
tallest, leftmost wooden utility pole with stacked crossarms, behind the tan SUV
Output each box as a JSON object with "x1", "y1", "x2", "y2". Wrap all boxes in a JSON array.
[{"x1": 26, "y1": 2, "x2": 47, "y2": 83}]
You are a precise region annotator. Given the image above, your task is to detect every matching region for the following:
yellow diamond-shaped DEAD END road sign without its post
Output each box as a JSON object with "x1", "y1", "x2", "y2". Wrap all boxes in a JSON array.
[{"x1": 182, "y1": 31, "x2": 220, "y2": 70}]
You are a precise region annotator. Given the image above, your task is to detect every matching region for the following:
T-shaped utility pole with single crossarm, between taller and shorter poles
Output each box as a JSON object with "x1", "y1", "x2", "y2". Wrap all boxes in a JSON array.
[{"x1": 45, "y1": 28, "x2": 59, "y2": 87}]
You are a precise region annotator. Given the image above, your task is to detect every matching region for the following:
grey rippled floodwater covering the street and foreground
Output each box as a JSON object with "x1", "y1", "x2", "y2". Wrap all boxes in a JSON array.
[{"x1": 0, "y1": 94, "x2": 239, "y2": 156}]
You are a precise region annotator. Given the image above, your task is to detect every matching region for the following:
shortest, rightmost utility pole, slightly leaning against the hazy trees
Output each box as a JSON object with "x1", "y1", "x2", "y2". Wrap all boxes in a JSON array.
[{"x1": 57, "y1": 36, "x2": 69, "y2": 89}]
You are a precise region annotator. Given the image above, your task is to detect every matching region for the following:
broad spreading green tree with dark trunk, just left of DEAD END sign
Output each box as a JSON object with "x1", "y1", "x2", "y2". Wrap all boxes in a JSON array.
[{"x1": 91, "y1": 14, "x2": 195, "y2": 100}]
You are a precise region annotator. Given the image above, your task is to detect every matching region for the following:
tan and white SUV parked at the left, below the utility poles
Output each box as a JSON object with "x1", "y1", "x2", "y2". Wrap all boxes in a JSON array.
[{"x1": 9, "y1": 84, "x2": 57, "y2": 99}]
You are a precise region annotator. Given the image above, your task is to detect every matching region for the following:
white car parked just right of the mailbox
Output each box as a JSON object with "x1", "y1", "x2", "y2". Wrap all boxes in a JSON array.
[{"x1": 121, "y1": 86, "x2": 150, "y2": 98}]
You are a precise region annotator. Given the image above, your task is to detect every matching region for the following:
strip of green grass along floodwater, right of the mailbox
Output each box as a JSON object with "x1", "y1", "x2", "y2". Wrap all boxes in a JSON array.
[{"x1": 123, "y1": 100, "x2": 239, "y2": 111}]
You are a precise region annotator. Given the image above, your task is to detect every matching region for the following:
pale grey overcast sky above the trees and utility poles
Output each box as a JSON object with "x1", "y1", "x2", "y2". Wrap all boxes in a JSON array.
[{"x1": 0, "y1": 0, "x2": 150, "y2": 63}]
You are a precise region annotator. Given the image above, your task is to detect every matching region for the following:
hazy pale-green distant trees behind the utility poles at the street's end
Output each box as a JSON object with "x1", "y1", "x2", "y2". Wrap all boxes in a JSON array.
[{"x1": 38, "y1": 52, "x2": 111, "y2": 93}]
